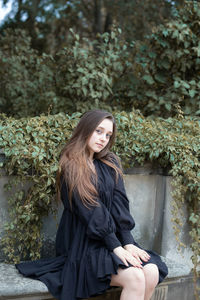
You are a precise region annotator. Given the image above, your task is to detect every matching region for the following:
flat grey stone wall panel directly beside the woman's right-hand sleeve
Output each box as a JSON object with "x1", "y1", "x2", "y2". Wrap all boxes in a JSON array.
[{"x1": 125, "y1": 174, "x2": 165, "y2": 253}]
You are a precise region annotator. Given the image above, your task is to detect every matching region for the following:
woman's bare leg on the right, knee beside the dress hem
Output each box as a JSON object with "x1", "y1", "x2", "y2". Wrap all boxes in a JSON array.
[{"x1": 143, "y1": 264, "x2": 159, "y2": 300}]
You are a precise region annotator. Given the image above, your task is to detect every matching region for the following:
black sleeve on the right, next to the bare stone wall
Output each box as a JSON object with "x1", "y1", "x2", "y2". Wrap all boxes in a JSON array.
[{"x1": 111, "y1": 171, "x2": 135, "y2": 246}]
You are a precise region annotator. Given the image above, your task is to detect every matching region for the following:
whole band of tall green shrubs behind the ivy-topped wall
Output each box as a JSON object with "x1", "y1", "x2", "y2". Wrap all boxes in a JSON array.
[{"x1": 0, "y1": 1, "x2": 200, "y2": 118}]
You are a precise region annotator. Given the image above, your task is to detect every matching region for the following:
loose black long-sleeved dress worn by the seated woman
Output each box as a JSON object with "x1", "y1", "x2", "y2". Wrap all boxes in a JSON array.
[{"x1": 16, "y1": 159, "x2": 168, "y2": 300}]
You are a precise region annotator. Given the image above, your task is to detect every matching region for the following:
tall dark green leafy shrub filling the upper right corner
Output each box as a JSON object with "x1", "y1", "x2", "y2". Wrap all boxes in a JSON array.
[{"x1": 133, "y1": 1, "x2": 200, "y2": 117}]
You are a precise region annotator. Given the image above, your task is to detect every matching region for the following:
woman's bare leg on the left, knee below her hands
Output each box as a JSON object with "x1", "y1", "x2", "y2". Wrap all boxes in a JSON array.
[{"x1": 110, "y1": 267, "x2": 145, "y2": 300}]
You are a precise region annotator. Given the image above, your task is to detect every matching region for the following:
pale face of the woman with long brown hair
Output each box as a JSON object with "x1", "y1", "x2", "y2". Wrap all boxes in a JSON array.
[{"x1": 87, "y1": 119, "x2": 113, "y2": 157}]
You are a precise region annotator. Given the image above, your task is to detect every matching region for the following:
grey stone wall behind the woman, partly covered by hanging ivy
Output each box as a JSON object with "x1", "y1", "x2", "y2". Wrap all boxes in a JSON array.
[{"x1": 0, "y1": 166, "x2": 192, "y2": 270}]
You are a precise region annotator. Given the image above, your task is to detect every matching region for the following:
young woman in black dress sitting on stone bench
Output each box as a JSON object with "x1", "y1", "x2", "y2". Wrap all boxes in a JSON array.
[{"x1": 16, "y1": 110, "x2": 167, "y2": 300}]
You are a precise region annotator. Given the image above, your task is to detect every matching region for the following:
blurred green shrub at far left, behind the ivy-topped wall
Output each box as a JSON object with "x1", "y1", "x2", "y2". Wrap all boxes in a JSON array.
[{"x1": 0, "y1": 30, "x2": 56, "y2": 117}]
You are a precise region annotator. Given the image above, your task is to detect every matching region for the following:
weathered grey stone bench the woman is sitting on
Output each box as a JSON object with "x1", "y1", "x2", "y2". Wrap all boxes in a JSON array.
[{"x1": 0, "y1": 259, "x2": 195, "y2": 300}]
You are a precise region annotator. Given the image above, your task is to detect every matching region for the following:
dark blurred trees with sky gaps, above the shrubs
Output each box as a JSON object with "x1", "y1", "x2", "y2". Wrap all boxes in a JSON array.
[{"x1": 1, "y1": 0, "x2": 177, "y2": 54}]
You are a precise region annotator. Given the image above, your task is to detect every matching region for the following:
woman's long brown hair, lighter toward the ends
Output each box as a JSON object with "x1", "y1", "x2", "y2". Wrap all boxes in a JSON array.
[{"x1": 57, "y1": 110, "x2": 122, "y2": 207}]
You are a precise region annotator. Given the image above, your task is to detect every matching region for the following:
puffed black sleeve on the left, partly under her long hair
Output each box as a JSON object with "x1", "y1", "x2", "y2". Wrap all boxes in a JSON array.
[{"x1": 61, "y1": 183, "x2": 121, "y2": 251}]
